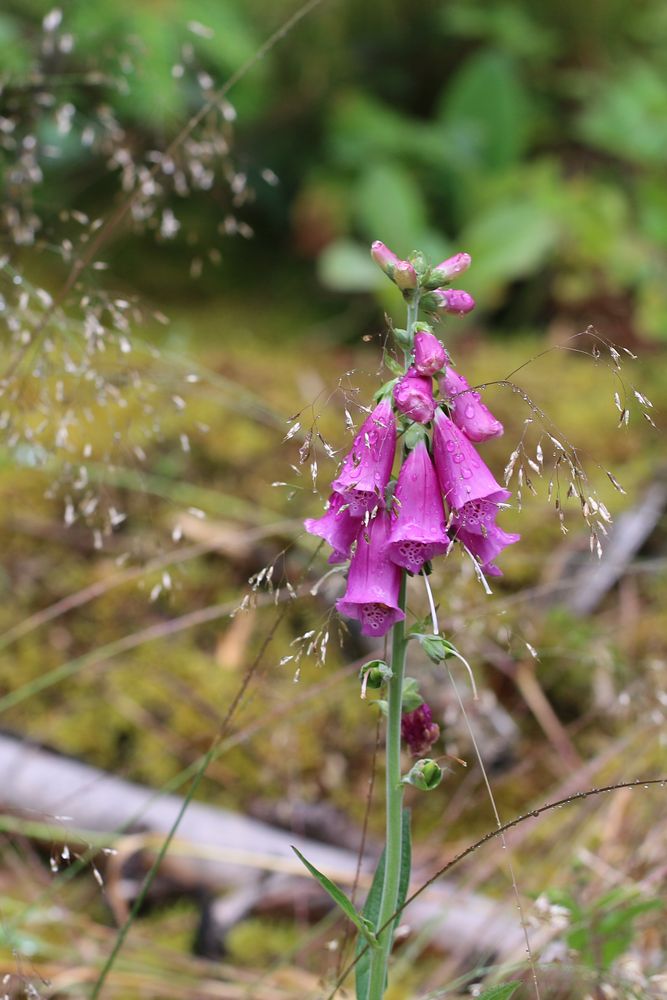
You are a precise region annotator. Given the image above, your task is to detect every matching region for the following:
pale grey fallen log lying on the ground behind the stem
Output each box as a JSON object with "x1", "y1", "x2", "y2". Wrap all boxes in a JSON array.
[{"x1": 0, "y1": 734, "x2": 523, "y2": 960}]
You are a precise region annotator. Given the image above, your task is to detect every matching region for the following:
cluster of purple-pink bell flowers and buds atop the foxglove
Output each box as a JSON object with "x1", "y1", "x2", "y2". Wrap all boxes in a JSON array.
[{"x1": 305, "y1": 244, "x2": 519, "y2": 637}]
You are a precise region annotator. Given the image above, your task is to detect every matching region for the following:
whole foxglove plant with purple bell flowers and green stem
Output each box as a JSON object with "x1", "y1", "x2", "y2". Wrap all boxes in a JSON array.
[{"x1": 305, "y1": 242, "x2": 519, "y2": 1000}]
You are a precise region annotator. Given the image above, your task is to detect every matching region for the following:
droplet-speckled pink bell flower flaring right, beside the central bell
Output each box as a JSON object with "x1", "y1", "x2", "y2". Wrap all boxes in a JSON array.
[{"x1": 433, "y1": 409, "x2": 512, "y2": 516}]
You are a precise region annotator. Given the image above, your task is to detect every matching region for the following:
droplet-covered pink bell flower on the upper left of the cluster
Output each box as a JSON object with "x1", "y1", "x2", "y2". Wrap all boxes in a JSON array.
[{"x1": 331, "y1": 399, "x2": 396, "y2": 517}]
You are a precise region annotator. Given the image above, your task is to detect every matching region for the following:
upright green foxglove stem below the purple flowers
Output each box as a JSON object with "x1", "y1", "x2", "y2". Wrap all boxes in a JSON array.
[{"x1": 367, "y1": 570, "x2": 407, "y2": 1000}]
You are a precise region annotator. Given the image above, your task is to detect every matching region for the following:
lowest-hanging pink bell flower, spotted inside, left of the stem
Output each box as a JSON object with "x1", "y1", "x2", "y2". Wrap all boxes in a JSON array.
[{"x1": 336, "y1": 510, "x2": 405, "y2": 638}]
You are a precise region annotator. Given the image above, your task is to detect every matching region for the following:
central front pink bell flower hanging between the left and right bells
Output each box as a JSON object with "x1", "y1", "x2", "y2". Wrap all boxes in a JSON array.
[{"x1": 389, "y1": 441, "x2": 450, "y2": 573}]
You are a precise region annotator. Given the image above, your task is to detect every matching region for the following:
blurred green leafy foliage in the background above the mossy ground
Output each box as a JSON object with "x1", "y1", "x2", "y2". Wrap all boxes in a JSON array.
[{"x1": 0, "y1": 0, "x2": 667, "y2": 340}]
